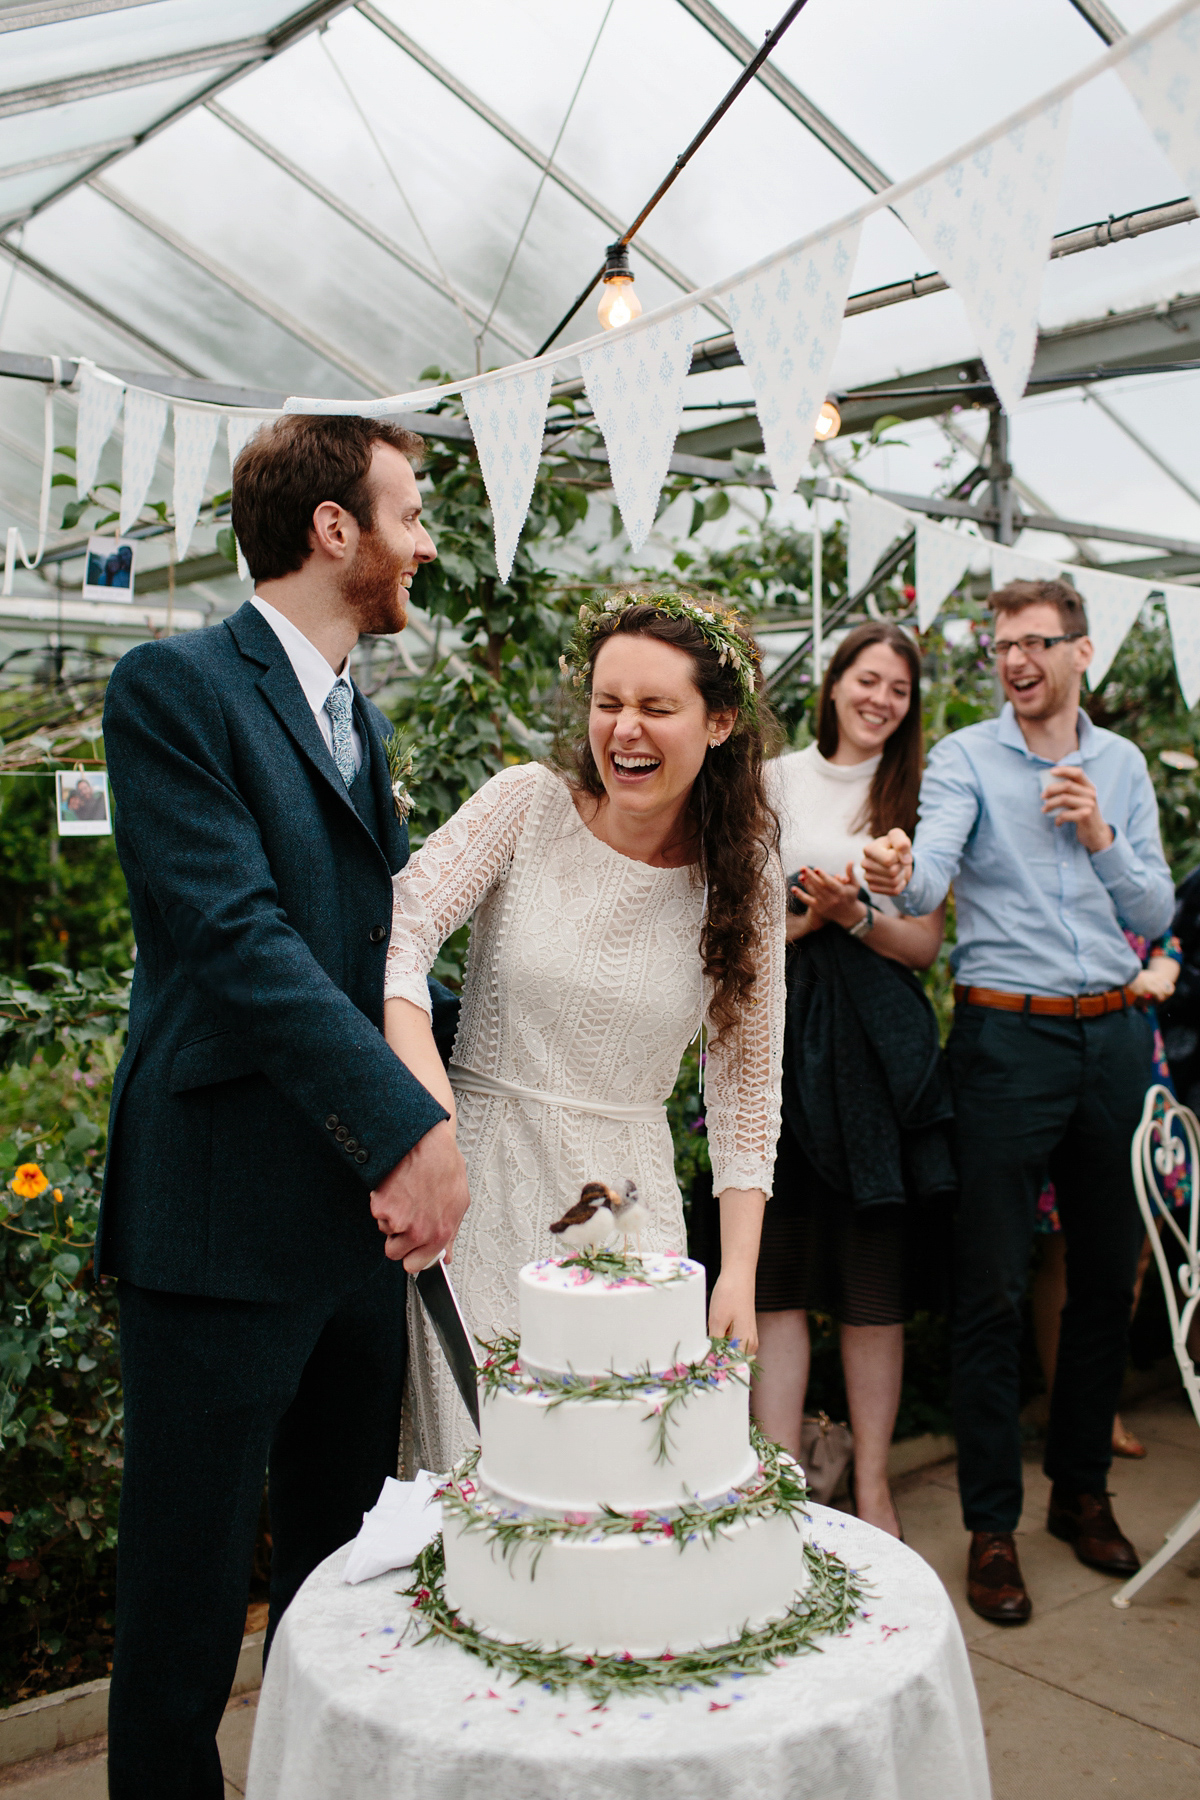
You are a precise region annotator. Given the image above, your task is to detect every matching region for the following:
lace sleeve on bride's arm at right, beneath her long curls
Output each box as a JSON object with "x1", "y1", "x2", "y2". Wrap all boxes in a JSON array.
[{"x1": 705, "y1": 855, "x2": 784, "y2": 1199}]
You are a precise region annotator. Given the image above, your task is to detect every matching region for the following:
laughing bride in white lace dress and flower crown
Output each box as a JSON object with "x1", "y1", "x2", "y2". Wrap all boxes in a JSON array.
[{"x1": 372, "y1": 594, "x2": 784, "y2": 1469}]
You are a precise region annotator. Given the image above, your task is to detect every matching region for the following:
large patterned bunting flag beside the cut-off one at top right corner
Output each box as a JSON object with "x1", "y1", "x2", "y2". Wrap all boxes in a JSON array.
[{"x1": 896, "y1": 101, "x2": 1070, "y2": 412}]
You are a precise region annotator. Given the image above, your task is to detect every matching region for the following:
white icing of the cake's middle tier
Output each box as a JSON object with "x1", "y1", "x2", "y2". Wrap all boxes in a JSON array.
[{"x1": 479, "y1": 1375, "x2": 757, "y2": 1512}]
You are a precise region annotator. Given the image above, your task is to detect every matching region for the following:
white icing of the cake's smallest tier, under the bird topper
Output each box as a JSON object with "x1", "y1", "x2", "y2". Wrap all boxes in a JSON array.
[{"x1": 518, "y1": 1256, "x2": 709, "y2": 1375}]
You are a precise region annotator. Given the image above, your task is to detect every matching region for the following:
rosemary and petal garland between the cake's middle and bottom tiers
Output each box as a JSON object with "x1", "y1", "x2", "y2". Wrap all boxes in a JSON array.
[{"x1": 437, "y1": 1424, "x2": 808, "y2": 1575}]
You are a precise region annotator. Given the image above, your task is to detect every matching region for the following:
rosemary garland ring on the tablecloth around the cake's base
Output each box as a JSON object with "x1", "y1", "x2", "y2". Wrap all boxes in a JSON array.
[{"x1": 401, "y1": 1537, "x2": 871, "y2": 1701}]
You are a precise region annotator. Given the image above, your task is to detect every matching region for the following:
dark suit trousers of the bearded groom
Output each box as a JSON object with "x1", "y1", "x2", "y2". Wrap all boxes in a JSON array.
[{"x1": 108, "y1": 1264, "x2": 407, "y2": 1800}]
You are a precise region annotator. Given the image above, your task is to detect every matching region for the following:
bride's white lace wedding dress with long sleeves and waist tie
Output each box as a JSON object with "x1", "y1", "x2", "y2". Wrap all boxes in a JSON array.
[{"x1": 383, "y1": 763, "x2": 784, "y2": 1469}]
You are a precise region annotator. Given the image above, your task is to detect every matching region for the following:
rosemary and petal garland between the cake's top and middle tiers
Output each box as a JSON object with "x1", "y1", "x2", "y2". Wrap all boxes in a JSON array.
[{"x1": 477, "y1": 1336, "x2": 756, "y2": 1463}]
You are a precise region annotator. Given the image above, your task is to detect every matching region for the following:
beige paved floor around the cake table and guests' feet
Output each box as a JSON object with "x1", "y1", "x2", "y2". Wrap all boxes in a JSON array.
[{"x1": 0, "y1": 1397, "x2": 1200, "y2": 1800}]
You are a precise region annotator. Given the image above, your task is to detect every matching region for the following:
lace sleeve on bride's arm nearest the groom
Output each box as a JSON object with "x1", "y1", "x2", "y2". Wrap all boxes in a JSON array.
[{"x1": 383, "y1": 763, "x2": 540, "y2": 1012}]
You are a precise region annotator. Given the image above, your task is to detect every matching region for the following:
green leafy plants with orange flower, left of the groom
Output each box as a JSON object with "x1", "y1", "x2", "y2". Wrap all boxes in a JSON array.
[{"x1": 0, "y1": 970, "x2": 130, "y2": 1703}]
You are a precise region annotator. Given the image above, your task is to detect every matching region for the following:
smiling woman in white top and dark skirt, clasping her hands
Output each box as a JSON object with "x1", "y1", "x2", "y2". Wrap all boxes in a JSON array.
[{"x1": 754, "y1": 621, "x2": 954, "y2": 1535}]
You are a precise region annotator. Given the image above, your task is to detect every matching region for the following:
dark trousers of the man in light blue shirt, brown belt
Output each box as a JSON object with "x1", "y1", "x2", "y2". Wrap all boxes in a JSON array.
[{"x1": 946, "y1": 1006, "x2": 1151, "y2": 1532}]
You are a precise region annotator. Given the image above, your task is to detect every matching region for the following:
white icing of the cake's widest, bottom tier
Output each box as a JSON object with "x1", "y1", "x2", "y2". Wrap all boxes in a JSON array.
[{"x1": 444, "y1": 1514, "x2": 808, "y2": 1656}]
